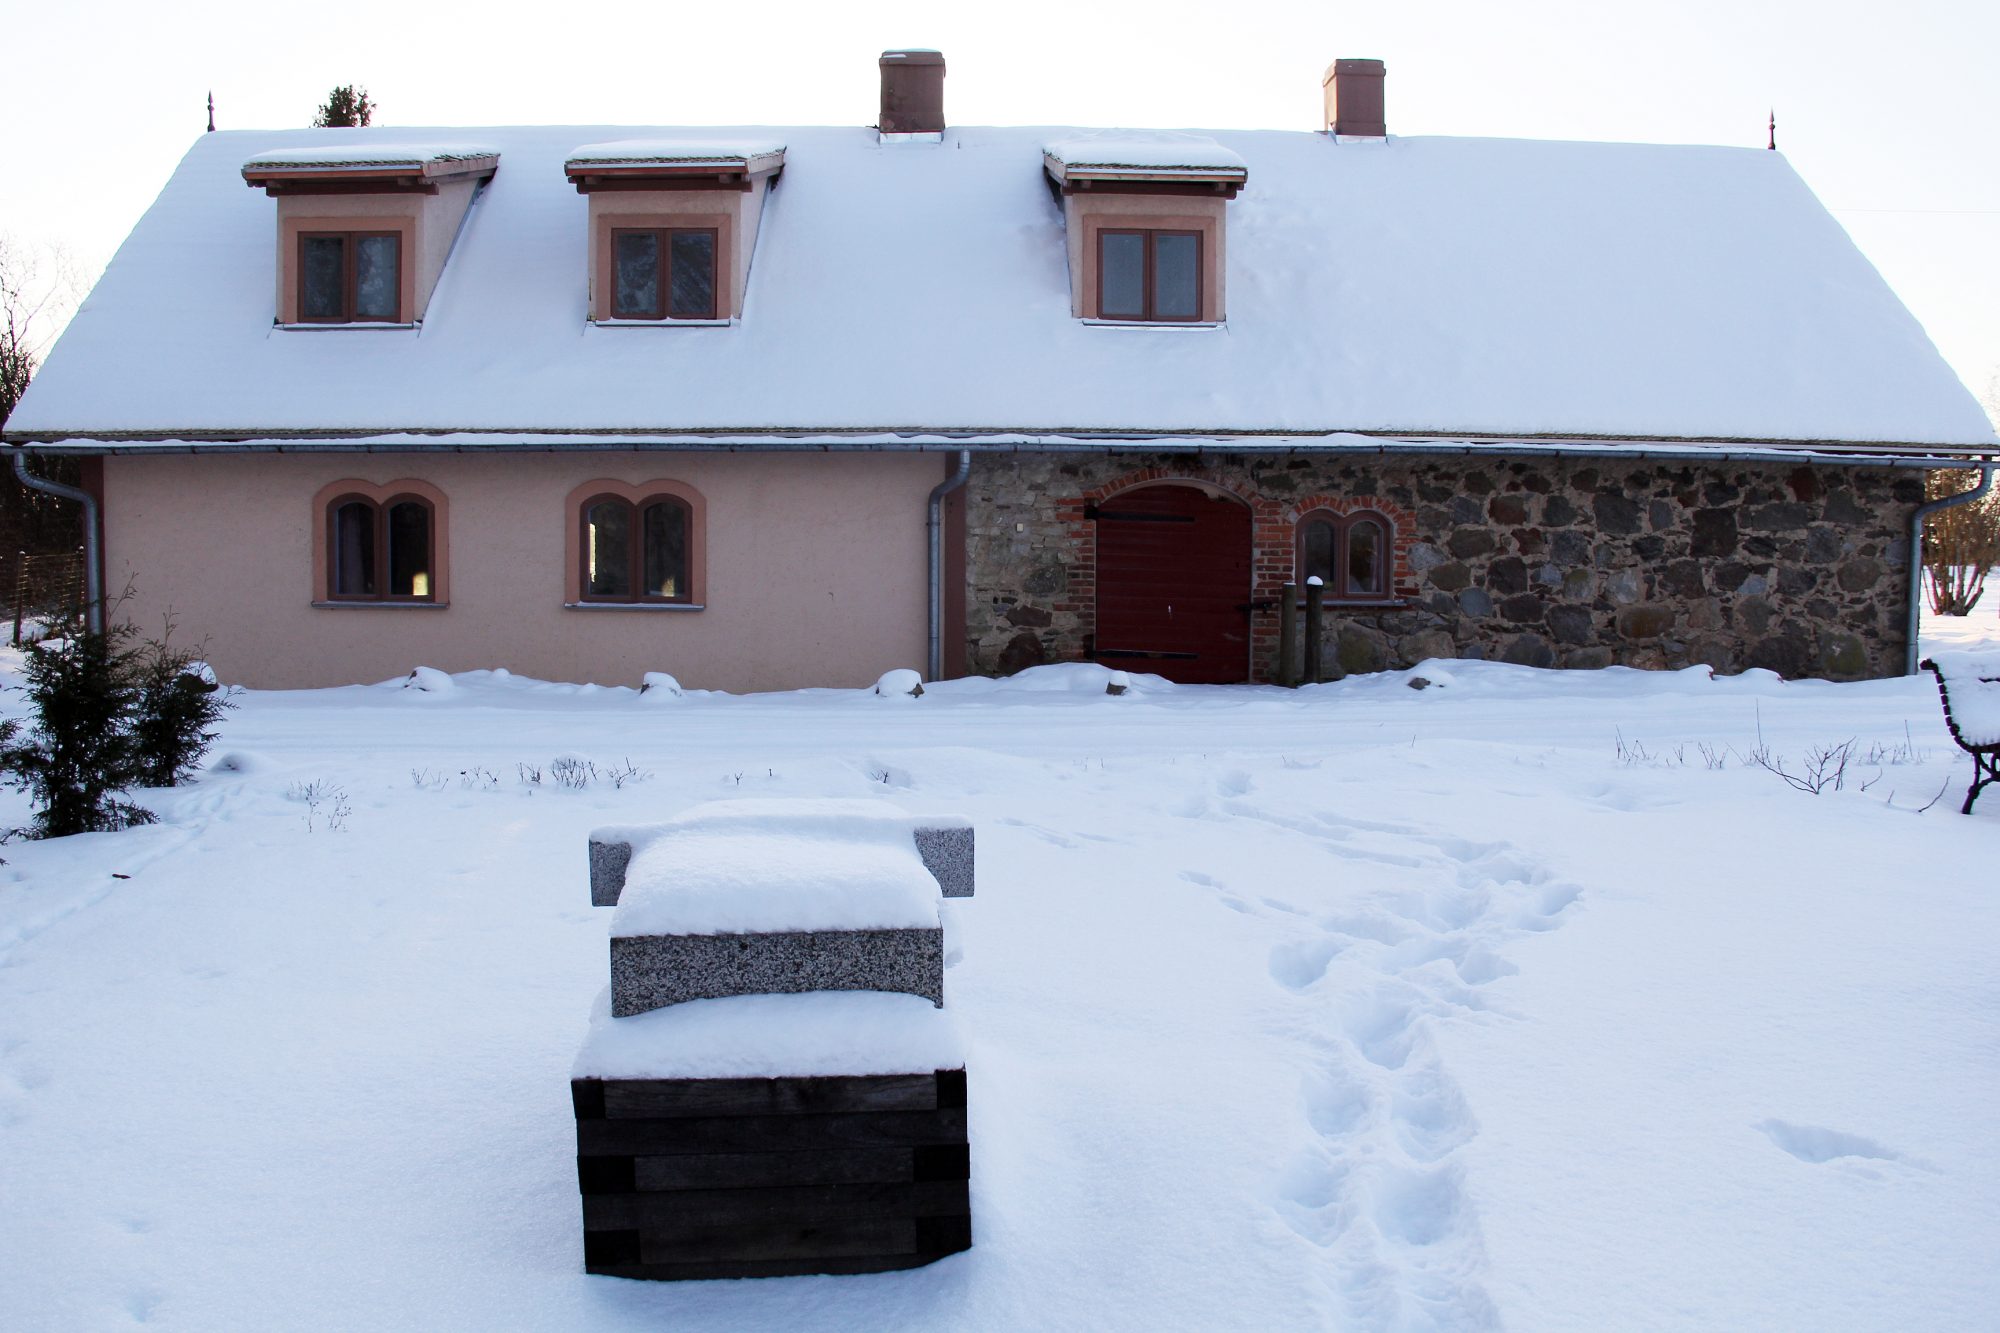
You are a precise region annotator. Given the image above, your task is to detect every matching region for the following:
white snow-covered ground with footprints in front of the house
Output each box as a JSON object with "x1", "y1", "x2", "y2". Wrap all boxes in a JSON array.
[{"x1": 0, "y1": 624, "x2": 2000, "y2": 1333}]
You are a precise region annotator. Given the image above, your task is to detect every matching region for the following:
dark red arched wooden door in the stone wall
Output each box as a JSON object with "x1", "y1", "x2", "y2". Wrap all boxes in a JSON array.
[{"x1": 1094, "y1": 484, "x2": 1250, "y2": 685}]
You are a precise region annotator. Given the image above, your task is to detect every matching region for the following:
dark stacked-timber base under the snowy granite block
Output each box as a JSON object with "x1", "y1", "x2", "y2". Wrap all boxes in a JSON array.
[{"x1": 570, "y1": 1069, "x2": 972, "y2": 1281}]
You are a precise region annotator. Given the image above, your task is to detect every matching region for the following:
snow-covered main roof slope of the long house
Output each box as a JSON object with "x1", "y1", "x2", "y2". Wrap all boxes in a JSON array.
[{"x1": 8, "y1": 126, "x2": 1996, "y2": 448}]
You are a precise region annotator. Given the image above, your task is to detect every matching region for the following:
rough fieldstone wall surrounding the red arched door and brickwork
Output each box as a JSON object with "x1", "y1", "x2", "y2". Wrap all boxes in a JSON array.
[{"x1": 966, "y1": 454, "x2": 1922, "y2": 681}]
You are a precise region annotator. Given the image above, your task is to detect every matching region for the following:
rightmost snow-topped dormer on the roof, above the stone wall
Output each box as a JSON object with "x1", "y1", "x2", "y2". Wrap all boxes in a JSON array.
[{"x1": 1042, "y1": 130, "x2": 1250, "y2": 324}]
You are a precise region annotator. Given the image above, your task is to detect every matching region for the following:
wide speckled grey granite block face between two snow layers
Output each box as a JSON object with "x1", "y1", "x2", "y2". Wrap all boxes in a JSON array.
[{"x1": 612, "y1": 927, "x2": 944, "y2": 1019}]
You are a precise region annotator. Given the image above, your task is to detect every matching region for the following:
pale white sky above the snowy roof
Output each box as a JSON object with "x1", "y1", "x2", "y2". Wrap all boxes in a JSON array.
[{"x1": 0, "y1": 0, "x2": 2000, "y2": 404}]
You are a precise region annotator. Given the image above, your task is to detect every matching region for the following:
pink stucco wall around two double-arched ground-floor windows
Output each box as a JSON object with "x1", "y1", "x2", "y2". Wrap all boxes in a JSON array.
[{"x1": 104, "y1": 452, "x2": 948, "y2": 691}]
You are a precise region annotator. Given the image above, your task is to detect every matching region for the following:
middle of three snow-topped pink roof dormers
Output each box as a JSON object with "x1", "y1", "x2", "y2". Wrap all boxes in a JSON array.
[{"x1": 562, "y1": 140, "x2": 784, "y2": 324}]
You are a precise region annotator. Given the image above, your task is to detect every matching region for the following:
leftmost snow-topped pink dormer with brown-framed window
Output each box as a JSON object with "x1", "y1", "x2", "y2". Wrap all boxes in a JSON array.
[{"x1": 244, "y1": 140, "x2": 500, "y2": 328}]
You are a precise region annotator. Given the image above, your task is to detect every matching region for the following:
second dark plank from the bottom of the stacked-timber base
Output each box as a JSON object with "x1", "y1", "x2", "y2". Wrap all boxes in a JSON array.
[{"x1": 584, "y1": 1181, "x2": 972, "y2": 1231}]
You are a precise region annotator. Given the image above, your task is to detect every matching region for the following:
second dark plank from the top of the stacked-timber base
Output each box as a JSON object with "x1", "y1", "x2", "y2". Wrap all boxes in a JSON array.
[{"x1": 576, "y1": 1109, "x2": 966, "y2": 1157}]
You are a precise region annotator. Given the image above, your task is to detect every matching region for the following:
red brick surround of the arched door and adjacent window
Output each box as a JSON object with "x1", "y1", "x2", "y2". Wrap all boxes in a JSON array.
[{"x1": 1054, "y1": 466, "x2": 1416, "y2": 681}]
